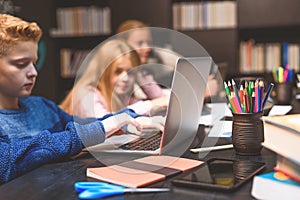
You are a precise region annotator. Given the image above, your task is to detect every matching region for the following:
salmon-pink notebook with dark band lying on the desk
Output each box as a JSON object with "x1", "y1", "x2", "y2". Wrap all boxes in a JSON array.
[{"x1": 86, "y1": 155, "x2": 203, "y2": 188}]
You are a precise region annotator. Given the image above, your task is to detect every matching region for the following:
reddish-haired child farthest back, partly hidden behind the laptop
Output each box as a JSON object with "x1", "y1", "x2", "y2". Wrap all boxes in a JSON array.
[{"x1": 117, "y1": 20, "x2": 219, "y2": 98}]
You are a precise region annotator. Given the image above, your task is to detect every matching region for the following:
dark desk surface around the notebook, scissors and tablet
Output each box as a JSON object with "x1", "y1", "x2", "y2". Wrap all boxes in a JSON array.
[{"x1": 0, "y1": 102, "x2": 300, "y2": 200}]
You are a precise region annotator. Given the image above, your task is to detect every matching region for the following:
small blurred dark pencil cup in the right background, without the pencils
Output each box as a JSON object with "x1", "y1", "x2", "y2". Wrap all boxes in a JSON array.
[{"x1": 275, "y1": 82, "x2": 293, "y2": 105}]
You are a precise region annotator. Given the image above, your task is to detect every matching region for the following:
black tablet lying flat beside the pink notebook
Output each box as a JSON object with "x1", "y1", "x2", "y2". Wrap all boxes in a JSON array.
[{"x1": 172, "y1": 158, "x2": 265, "y2": 192}]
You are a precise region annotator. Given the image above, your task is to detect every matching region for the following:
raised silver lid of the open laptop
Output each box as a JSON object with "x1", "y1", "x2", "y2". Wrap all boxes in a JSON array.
[{"x1": 160, "y1": 57, "x2": 213, "y2": 157}]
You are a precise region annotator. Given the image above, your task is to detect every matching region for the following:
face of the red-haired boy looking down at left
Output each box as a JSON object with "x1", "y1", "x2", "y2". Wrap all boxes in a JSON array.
[{"x1": 0, "y1": 41, "x2": 38, "y2": 99}]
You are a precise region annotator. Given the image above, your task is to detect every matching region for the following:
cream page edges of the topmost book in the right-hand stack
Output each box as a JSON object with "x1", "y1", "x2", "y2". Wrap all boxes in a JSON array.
[{"x1": 262, "y1": 123, "x2": 300, "y2": 163}]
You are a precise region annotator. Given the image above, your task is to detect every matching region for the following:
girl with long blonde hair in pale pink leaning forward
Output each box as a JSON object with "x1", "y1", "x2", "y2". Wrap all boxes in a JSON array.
[{"x1": 60, "y1": 38, "x2": 168, "y2": 117}]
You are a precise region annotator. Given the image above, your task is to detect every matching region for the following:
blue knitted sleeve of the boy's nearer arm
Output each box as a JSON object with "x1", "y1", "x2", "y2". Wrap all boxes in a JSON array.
[{"x1": 0, "y1": 121, "x2": 105, "y2": 184}]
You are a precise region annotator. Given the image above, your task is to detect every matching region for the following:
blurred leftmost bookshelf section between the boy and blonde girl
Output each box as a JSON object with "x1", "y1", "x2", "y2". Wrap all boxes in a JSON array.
[{"x1": 48, "y1": 0, "x2": 112, "y2": 103}]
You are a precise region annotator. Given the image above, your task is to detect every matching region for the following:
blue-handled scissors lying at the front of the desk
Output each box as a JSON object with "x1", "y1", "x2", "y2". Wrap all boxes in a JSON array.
[{"x1": 74, "y1": 182, "x2": 170, "y2": 199}]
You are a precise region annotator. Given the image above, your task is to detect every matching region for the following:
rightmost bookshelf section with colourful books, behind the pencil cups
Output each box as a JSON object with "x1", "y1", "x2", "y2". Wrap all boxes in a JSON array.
[{"x1": 237, "y1": 0, "x2": 300, "y2": 77}]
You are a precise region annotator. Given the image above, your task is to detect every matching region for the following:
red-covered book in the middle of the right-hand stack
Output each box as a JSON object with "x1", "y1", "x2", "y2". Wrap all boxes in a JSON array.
[{"x1": 274, "y1": 155, "x2": 300, "y2": 183}]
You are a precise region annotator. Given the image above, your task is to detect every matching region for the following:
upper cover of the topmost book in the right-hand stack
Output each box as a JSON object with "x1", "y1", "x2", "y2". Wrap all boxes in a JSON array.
[{"x1": 262, "y1": 114, "x2": 300, "y2": 134}]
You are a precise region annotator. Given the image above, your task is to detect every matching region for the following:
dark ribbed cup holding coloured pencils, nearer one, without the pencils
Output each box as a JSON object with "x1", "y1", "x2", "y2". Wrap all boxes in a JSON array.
[{"x1": 232, "y1": 112, "x2": 264, "y2": 155}]
